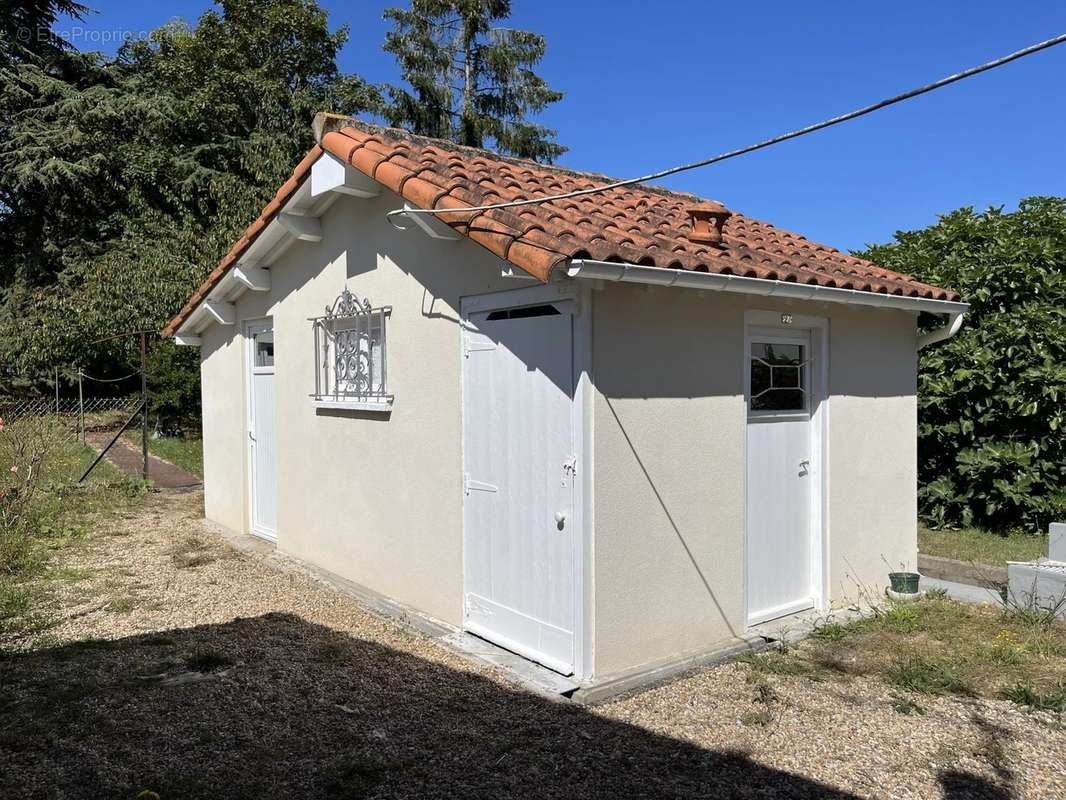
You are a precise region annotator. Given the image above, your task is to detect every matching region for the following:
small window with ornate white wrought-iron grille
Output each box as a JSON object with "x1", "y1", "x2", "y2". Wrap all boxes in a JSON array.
[{"x1": 311, "y1": 288, "x2": 392, "y2": 407}]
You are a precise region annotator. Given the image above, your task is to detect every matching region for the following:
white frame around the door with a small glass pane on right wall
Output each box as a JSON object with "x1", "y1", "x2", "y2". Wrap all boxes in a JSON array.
[{"x1": 741, "y1": 310, "x2": 829, "y2": 628}]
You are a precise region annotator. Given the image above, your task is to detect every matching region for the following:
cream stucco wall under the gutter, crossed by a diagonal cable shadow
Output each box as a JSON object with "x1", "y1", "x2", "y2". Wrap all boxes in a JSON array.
[{"x1": 593, "y1": 285, "x2": 916, "y2": 675}]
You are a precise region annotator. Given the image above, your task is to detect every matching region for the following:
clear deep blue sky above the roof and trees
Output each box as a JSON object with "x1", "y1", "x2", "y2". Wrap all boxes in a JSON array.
[{"x1": 59, "y1": 0, "x2": 1066, "y2": 249}]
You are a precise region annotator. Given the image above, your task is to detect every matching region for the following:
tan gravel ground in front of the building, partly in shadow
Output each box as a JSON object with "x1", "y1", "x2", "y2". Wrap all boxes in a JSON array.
[{"x1": 0, "y1": 494, "x2": 1066, "y2": 800}]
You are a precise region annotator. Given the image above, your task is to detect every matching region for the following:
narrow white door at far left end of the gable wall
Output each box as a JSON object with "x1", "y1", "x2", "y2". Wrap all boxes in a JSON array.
[{"x1": 245, "y1": 320, "x2": 277, "y2": 540}]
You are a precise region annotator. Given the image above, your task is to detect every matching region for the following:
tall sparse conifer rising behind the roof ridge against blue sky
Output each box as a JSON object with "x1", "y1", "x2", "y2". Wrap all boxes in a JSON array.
[{"x1": 385, "y1": 0, "x2": 566, "y2": 162}]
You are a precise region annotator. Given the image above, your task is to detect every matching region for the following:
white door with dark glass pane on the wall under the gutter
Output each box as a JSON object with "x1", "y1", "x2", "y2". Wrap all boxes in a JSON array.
[{"x1": 746, "y1": 327, "x2": 818, "y2": 625}]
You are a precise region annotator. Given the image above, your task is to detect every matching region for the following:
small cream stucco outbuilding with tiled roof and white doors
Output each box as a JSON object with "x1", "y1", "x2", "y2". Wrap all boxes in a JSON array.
[{"x1": 166, "y1": 115, "x2": 966, "y2": 699}]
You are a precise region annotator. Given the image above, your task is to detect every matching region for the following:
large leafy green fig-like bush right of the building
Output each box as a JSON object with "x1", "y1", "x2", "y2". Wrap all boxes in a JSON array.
[{"x1": 857, "y1": 197, "x2": 1066, "y2": 530}]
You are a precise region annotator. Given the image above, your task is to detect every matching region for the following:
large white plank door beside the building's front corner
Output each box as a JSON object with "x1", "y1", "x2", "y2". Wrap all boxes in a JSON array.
[{"x1": 463, "y1": 301, "x2": 580, "y2": 675}]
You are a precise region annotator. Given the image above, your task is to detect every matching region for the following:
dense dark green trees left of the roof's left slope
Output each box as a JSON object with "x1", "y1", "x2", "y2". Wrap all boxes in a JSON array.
[{"x1": 0, "y1": 0, "x2": 377, "y2": 403}]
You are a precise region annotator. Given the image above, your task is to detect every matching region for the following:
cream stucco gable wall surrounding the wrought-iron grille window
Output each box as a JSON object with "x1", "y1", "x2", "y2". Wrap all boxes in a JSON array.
[{"x1": 203, "y1": 191, "x2": 518, "y2": 625}]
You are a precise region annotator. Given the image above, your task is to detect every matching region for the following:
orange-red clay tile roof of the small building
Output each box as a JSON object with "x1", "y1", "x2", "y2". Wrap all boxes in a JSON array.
[{"x1": 164, "y1": 119, "x2": 959, "y2": 335}]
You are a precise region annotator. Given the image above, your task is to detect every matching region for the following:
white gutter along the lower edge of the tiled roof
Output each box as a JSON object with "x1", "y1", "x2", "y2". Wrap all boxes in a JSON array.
[{"x1": 566, "y1": 258, "x2": 970, "y2": 348}]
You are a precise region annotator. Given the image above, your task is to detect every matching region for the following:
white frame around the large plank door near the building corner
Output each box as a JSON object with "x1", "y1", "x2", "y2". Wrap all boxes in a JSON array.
[{"x1": 459, "y1": 284, "x2": 593, "y2": 681}]
